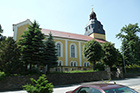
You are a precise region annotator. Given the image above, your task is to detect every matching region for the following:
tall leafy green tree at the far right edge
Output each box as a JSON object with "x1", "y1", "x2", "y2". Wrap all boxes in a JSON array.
[{"x1": 116, "y1": 23, "x2": 140, "y2": 64}]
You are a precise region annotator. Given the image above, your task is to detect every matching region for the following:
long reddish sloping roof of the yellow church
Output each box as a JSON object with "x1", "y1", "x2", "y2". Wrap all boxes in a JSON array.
[{"x1": 41, "y1": 29, "x2": 106, "y2": 43}]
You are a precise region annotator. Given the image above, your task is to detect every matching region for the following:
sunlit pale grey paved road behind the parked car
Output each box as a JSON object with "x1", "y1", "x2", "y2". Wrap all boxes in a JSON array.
[{"x1": 0, "y1": 77, "x2": 140, "y2": 93}]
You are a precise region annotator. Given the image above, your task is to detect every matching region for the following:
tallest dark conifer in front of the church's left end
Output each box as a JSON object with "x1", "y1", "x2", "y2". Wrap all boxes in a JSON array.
[{"x1": 18, "y1": 21, "x2": 44, "y2": 69}]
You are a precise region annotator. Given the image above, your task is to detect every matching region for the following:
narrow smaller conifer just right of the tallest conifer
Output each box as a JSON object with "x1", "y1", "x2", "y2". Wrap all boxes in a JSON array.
[{"x1": 43, "y1": 33, "x2": 58, "y2": 72}]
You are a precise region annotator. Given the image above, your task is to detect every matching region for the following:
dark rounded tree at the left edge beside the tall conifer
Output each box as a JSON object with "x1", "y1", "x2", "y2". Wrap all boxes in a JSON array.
[{"x1": 0, "y1": 37, "x2": 21, "y2": 73}]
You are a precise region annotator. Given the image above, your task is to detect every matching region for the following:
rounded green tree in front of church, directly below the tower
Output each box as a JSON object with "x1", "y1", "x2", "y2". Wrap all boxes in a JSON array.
[{"x1": 84, "y1": 39, "x2": 104, "y2": 70}]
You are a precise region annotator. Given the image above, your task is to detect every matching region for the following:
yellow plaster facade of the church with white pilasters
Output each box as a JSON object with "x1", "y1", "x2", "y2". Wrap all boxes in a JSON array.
[{"x1": 14, "y1": 19, "x2": 99, "y2": 71}]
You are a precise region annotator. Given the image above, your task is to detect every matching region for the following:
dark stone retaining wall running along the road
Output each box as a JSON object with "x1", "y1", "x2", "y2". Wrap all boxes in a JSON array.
[{"x1": 0, "y1": 71, "x2": 110, "y2": 91}]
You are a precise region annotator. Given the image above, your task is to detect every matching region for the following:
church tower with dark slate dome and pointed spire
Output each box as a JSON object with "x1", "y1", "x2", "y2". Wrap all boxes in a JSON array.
[{"x1": 85, "y1": 10, "x2": 106, "y2": 40}]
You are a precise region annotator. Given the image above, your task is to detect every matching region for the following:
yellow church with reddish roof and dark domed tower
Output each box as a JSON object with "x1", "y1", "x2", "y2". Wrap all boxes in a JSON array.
[{"x1": 13, "y1": 10, "x2": 106, "y2": 71}]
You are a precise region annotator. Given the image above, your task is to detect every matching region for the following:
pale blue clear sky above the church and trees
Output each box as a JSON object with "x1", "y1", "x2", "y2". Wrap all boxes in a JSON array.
[{"x1": 0, "y1": 0, "x2": 140, "y2": 49}]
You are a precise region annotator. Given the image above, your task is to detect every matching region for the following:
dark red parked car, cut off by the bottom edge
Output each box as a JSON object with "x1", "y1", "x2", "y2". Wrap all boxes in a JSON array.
[{"x1": 66, "y1": 83, "x2": 138, "y2": 93}]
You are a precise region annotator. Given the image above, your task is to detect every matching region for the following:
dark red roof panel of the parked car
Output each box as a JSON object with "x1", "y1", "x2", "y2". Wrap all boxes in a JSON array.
[{"x1": 82, "y1": 83, "x2": 126, "y2": 90}]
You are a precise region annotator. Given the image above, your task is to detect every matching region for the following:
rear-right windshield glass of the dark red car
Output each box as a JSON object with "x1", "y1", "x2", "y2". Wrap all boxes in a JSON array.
[{"x1": 104, "y1": 87, "x2": 138, "y2": 93}]
